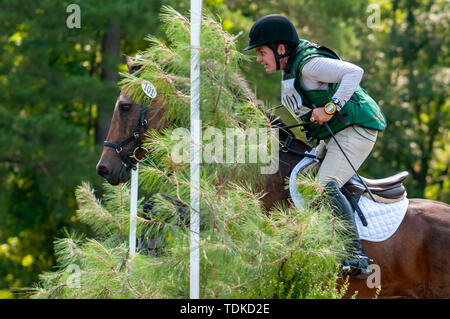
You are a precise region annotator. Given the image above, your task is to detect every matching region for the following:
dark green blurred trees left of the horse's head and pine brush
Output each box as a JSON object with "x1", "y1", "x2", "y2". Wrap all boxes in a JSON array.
[{"x1": 0, "y1": 0, "x2": 171, "y2": 296}]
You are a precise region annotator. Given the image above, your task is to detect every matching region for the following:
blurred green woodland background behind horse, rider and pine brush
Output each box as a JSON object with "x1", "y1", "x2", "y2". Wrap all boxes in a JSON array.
[{"x1": 0, "y1": 0, "x2": 450, "y2": 298}]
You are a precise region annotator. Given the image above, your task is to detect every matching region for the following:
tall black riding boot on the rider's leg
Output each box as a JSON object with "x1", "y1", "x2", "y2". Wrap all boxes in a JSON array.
[{"x1": 325, "y1": 182, "x2": 370, "y2": 278}]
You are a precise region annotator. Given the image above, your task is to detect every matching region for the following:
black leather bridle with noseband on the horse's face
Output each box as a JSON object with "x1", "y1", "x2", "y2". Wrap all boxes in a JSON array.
[{"x1": 103, "y1": 105, "x2": 148, "y2": 169}]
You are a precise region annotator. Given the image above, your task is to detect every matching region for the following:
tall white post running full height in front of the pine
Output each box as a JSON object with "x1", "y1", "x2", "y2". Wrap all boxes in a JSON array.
[{"x1": 189, "y1": 0, "x2": 202, "y2": 299}]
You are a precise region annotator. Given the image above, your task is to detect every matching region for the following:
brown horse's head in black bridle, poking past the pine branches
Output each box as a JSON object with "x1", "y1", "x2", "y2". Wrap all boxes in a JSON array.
[{"x1": 96, "y1": 56, "x2": 165, "y2": 185}]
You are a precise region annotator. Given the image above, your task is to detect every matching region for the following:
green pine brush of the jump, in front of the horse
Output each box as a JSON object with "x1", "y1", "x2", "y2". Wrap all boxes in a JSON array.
[{"x1": 34, "y1": 8, "x2": 345, "y2": 298}]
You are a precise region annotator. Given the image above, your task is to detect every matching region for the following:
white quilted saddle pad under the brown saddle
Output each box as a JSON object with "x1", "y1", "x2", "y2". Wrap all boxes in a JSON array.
[{"x1": 289, "y1": 149, "x2": 409, "y2": 242}]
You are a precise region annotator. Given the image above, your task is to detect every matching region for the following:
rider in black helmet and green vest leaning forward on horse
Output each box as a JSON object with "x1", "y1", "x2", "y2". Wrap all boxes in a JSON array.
[{"x1": 245, "y1": 14, "x2": 386, "y2": 276}]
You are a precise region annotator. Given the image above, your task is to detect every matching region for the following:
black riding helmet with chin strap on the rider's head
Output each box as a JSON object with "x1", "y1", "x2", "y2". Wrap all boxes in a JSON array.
[{"x1": 244, "y1": 14, "x2": 300, "y2": 70}]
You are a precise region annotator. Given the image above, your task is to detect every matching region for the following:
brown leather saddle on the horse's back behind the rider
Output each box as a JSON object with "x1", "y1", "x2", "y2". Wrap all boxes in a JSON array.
[{"x1": 342, "y1": 171, "x2": 409, "y2": 204}]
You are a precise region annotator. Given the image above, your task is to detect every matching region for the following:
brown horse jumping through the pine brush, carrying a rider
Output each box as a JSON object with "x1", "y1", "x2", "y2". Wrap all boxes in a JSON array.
[{"x1": 96, "y1": 57, "x2": 450, "y2": 298}]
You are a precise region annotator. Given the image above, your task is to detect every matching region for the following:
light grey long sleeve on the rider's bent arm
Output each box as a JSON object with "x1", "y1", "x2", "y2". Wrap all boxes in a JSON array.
[{"x1": 300, "y1": 57, "x2": 364, "y2": 106}]
